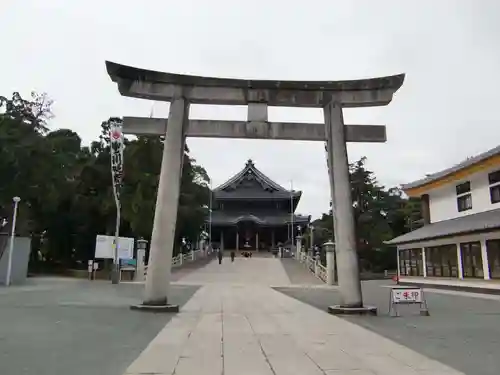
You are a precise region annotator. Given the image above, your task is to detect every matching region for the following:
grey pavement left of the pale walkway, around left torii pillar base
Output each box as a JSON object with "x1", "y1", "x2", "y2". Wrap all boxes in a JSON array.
[{"x1": 0, "y1": 277, "x2": 198, "y2": 375}]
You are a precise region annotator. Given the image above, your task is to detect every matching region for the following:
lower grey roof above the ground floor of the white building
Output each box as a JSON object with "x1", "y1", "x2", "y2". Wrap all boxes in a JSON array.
[{"x1": 386, "y1": 208, "x2": 500, "y2": 245}]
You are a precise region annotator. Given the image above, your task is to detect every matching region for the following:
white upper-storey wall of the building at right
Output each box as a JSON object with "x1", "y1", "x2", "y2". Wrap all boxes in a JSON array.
[{"x1": 428, "y1": 166, "x2": 500, "y2": 223}]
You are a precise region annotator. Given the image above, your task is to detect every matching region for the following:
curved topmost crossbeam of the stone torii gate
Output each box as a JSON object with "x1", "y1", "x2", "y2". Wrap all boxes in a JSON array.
[{"x1": 106, "y1": 61, "x2": 405, "y2": 108}]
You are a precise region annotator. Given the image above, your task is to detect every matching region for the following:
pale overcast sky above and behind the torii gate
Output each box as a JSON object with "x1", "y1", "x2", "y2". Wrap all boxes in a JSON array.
[{"x1": 0, "y1": 0, "x2": 500, "y2": 216}]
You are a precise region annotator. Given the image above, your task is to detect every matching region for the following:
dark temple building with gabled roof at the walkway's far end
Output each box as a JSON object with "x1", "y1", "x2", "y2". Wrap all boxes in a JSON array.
[{"x1": 207, "y1": 160, "x2": 311, "y2": 251}]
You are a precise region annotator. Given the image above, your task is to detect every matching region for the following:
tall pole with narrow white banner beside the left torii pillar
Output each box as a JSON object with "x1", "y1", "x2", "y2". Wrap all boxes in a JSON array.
[{"x1": 109, "y1": 121, "x2": 123, "y2": 284}]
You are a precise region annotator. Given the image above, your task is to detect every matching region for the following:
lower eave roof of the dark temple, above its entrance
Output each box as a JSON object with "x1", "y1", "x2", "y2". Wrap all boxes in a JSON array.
[{"x1": 212, "y1": 211, "x2": 311, "y2": 225}]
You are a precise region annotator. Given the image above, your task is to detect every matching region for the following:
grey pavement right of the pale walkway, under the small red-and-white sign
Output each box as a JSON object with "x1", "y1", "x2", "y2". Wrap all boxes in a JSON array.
[{"x1": 275, "y1": 280, "x2": 500, "y2": 375}]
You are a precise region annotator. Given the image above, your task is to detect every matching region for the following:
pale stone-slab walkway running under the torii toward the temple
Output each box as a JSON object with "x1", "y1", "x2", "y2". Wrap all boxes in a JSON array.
[{"x1": 126, "y1": 258, "x2": 461, "y2": 375}]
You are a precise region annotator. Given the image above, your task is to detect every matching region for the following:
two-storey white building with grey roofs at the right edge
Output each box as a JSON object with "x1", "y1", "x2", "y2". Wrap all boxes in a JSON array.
[{"x1": 387, "y1": 146, "x2": 500, "y2": 289}]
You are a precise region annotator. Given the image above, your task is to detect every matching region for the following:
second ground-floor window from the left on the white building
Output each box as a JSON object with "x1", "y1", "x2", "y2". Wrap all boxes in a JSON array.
[{"x1": 425, "y1": 244, "x2": 458, "y2": 277}]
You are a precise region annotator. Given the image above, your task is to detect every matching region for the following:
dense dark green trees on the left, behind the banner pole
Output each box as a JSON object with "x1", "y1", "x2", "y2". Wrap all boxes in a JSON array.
[{"x1": 0, "y1": 93, "x2": 209, "y2": 270}]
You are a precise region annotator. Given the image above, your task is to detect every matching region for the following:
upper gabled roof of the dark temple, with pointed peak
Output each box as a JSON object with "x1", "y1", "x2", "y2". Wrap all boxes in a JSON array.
[{"x1": 213, "y1": 159, "x2": 302, "y2": 200}]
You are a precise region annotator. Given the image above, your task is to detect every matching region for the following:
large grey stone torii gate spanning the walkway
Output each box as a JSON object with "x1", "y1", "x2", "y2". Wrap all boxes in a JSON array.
[{"x1": 106, "y1": 61, "x2": 404, "y2": 313}]
